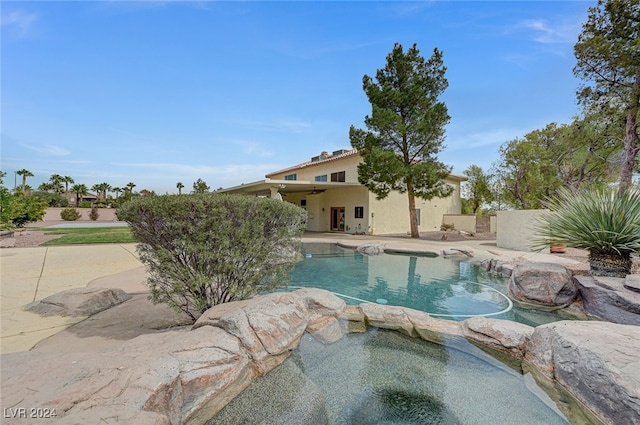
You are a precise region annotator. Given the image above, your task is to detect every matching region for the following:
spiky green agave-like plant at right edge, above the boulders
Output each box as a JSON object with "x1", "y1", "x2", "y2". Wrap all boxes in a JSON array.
[{"x1": 534, "y1": 187, "x2": 640, "y2": 277}]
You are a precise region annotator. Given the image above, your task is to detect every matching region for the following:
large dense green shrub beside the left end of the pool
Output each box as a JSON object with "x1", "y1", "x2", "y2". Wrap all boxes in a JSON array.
[{"x1": 117, "y1": 193, "x2": 306, "y2": 320}]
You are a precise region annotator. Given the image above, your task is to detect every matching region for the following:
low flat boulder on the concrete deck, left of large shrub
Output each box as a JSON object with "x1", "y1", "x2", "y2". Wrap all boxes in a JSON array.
[{"x1": 24, "y1": 288, "x2": 131, "y2": 316}]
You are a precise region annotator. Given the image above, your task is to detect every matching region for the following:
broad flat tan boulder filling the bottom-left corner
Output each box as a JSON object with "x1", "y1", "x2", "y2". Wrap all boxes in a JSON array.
[{"x1": 0, "y1": 327, "x2": 253, "y2": 424}]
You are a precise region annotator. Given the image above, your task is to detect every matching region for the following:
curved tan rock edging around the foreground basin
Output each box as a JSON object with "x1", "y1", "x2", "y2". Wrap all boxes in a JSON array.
[{"x1": 0, "y1": 288, "x2": 640, "y2": 425}]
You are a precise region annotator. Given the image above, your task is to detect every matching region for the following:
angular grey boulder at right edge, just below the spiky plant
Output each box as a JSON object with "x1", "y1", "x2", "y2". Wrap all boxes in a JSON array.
[{"x1": 575, "y1": 275, "x2": 640, "y2": 325}]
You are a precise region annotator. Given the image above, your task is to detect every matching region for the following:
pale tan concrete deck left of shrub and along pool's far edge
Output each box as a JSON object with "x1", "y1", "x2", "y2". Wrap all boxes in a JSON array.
[{"x1": 0, "y1": 233, "x2": 577, "y2": 353}]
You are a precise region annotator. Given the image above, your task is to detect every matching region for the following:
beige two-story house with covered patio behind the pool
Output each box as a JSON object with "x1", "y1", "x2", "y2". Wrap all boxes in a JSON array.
[{"x1": 219, "y1": 149, "x2": 465, "y2": 234}]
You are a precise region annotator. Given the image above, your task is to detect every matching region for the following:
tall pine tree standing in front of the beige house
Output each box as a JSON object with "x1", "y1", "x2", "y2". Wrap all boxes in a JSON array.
[{"x1": 349, "y1": 43, "x2": 453, "y2": 238}]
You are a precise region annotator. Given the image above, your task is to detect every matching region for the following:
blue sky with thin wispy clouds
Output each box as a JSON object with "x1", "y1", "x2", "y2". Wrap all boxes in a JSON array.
[{"x1": 0, "y1": 1, "x2": 596, "y2": 194}]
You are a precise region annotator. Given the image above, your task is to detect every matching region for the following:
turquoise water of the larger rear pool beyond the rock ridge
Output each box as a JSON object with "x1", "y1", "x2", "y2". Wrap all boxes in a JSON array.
[{"x1": 289, "y1": 243, "x2": 566, "y2": 326}]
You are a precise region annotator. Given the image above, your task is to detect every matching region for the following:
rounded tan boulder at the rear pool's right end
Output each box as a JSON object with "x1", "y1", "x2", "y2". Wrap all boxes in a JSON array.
[{"x1": 508, "y1": 263, "x2": 578, "y2": 307}]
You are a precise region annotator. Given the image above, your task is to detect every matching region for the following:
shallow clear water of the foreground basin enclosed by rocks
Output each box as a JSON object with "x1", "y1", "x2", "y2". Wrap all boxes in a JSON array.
[{"x1": 208, "y1": 329, "x2": 568, "y2": 425}]
